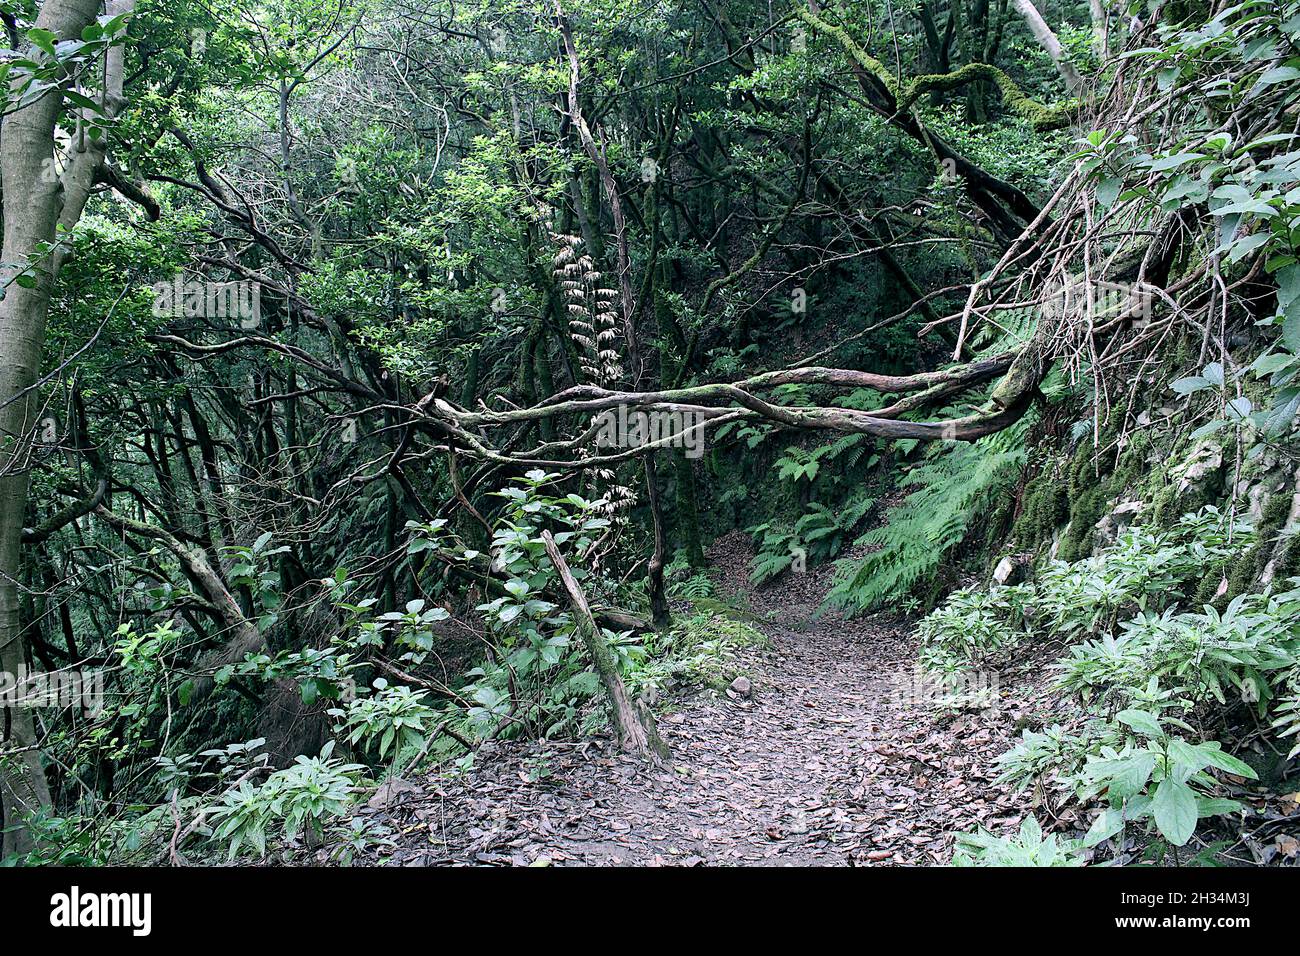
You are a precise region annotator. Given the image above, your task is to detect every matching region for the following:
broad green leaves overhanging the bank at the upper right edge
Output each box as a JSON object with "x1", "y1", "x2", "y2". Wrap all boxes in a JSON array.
[{"x1": 1076, "y1": 3, "x2": 1300, "y2": 454}]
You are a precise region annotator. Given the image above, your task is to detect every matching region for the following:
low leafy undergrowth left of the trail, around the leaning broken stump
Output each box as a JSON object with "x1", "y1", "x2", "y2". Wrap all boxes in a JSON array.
[{"x1": 8, "y1": 471, "x2": 767, "y2": 865}]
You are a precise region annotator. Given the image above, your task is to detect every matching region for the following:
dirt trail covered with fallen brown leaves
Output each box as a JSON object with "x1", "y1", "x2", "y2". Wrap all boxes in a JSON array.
[{"x1": 358, "y1": 546, "x2": 1041, "y2": 866}]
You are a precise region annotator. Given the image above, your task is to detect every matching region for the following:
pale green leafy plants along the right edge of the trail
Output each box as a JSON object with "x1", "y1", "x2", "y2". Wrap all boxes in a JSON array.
[{"x1": 946, "y1": 507, "x2": 1300, "y2": 860}]
